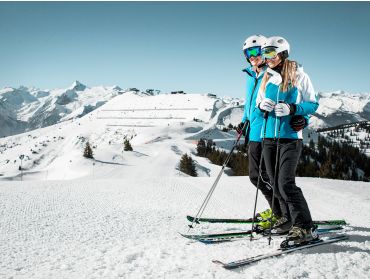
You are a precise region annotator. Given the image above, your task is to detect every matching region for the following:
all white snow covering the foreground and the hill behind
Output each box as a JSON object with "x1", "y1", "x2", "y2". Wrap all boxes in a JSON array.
[{"x1": 0, "y1": 87, "x2": 370, "y2": 278}]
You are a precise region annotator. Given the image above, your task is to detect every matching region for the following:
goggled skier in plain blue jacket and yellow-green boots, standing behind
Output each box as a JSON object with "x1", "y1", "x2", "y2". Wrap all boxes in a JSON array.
[{"x1": 237, "y1": 35, "x2": 305, "y2": 229}]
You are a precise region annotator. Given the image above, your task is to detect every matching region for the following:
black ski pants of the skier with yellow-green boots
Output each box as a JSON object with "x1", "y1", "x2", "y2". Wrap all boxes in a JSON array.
[{"x1": 248, "y1": 141, "x2": 287, "y2": 217}]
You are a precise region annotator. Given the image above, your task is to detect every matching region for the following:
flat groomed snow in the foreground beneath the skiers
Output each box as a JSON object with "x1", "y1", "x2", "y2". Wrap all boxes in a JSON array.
[{"x1": 0, "y1": 177, "x2": 370, "y2": 278}]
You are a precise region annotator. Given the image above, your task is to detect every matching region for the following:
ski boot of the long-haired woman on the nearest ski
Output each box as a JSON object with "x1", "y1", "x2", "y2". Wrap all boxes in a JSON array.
[{"x1": 280, "y1": 226, "x2": 319, "y2": 248}]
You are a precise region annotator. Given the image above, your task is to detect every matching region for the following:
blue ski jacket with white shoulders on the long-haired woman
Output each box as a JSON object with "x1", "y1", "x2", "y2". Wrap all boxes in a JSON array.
[{"x1": 256, "y1": 66, "x2": 319, "y2": 139}]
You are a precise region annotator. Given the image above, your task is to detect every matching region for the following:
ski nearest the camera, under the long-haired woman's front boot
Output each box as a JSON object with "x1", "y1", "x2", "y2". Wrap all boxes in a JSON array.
[{"x1": 212, "y1": 235, "x2": 348, "y2": 269}]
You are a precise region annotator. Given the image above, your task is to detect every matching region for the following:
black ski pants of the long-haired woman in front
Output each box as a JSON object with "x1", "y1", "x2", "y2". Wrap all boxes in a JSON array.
[{"x1": 263, "y1": 139, "x2": 313, "y2": 229}]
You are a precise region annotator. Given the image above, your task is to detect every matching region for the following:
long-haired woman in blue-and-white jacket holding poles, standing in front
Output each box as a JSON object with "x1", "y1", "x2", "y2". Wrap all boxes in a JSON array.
[{"x1": 256, "y1": 36, "x2": 319, "y2": 244}]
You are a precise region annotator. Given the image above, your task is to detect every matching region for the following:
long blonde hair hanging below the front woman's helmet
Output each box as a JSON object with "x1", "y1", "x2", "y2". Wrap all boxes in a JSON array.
[{"x1": 261, "y1": 59, "x2": 298, "y2": 92}]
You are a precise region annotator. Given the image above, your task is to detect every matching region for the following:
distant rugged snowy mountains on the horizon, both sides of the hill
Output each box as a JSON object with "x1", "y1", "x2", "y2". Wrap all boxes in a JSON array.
[{"x1": 0, "y1": 81, "x2": 370, "y2": 137}]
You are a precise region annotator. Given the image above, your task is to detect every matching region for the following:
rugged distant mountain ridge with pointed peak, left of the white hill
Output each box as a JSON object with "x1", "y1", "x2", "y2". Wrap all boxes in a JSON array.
[{"x1": 0, "y1": 81, "x2": 122, "y2": 137}]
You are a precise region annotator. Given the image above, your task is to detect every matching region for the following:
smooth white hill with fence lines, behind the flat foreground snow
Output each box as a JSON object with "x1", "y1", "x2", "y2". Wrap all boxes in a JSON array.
[{"x1": 0, "y1": 92, "x2": 235, "y2": 180}]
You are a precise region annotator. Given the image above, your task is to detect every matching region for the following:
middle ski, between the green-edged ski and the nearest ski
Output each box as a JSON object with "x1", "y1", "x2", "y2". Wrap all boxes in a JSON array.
[{"x1": 180, "y1": 226, "x2": 343, "y2": 244}]
